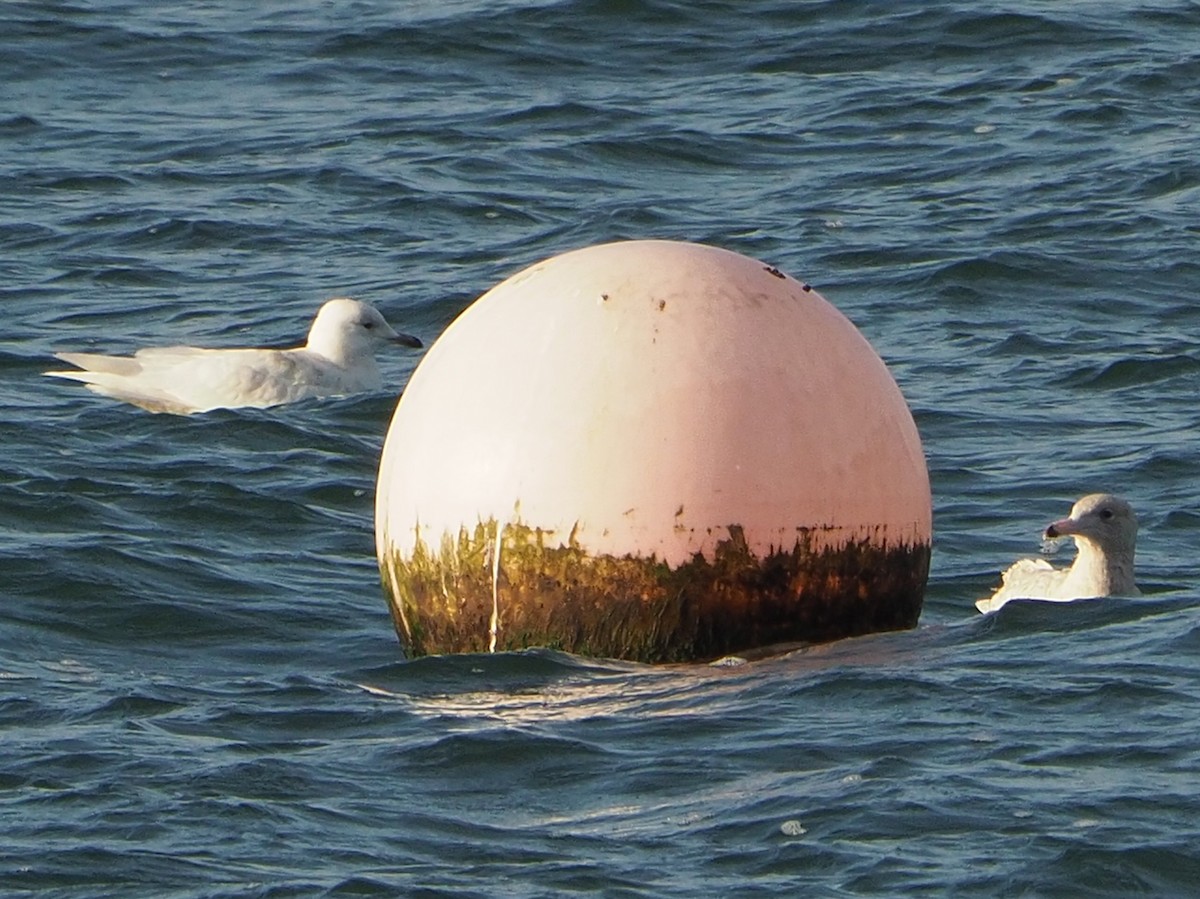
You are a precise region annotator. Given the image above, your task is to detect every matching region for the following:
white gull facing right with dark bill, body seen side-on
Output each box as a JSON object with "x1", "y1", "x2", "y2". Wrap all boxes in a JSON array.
[{"x1": 46, "y1": 296, "x2": 421, "y2": 415}]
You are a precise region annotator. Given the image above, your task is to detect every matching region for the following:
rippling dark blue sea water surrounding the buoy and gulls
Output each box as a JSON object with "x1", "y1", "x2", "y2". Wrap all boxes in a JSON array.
[{"x1": 0, "y1": 0, "x2": 1200, "y2": 897}]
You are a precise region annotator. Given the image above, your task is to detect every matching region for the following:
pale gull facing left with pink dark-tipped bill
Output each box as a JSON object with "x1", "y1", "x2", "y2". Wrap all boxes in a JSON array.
[{"x1": 976, "y1": 493, "x2": 1139, "y2": 613}]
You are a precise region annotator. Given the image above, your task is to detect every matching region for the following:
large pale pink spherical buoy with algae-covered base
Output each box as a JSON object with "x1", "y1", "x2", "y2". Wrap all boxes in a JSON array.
[{"x1": 376, "y1": 240, "x2": 932, "y2": 661}]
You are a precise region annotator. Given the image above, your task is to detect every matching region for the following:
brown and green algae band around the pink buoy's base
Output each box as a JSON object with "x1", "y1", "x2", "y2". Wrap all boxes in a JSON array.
[{"x1": 380, "y1": 521, "x2": 930, "y2": 663}]
